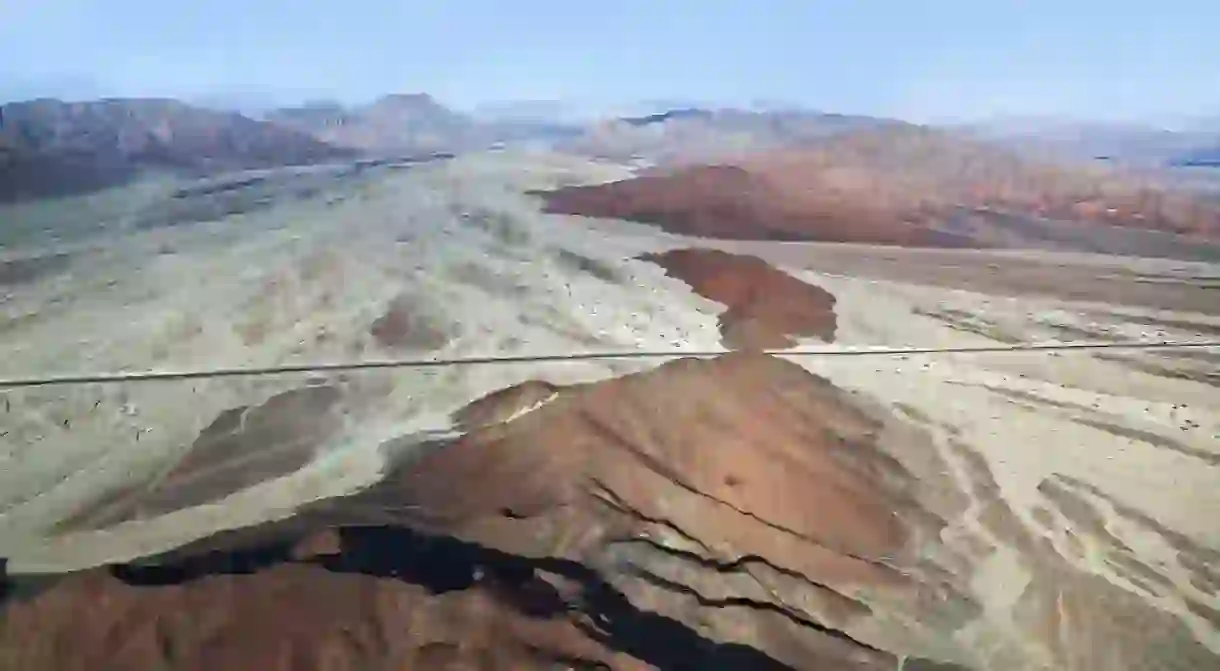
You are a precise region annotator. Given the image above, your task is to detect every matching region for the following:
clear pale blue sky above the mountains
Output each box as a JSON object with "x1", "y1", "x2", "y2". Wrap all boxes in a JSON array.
[{"x1": 0, "y1": 0, "x2": 1220, "y2": 120}]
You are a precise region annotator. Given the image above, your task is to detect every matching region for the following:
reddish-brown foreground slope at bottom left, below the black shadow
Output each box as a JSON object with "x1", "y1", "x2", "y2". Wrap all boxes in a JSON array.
[{"x1": 0, "y1": 551, "x2": 648, "y2": 671}]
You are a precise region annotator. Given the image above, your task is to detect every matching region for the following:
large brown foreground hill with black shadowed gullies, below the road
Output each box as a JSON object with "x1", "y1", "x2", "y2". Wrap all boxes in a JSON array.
[{"x1": 11, "y1": 353, "x2": 1220, "y2": 671}]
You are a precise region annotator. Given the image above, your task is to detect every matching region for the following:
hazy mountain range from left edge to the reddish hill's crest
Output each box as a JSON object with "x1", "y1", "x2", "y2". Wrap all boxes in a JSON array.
[{"x1": 0, "y1": 93, "x2": 897, "y2": 201}]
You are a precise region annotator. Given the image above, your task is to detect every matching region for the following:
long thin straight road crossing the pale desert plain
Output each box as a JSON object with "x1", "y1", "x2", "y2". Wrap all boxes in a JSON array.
[{"x1": 0, "y1": 340, "x2": 1220, "y2": 389}]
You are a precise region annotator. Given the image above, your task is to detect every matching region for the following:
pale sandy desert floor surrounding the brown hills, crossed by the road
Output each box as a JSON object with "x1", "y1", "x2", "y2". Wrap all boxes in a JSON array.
[{"x1": 0, "y1": 154, "x2": 1220, "y2": 669}]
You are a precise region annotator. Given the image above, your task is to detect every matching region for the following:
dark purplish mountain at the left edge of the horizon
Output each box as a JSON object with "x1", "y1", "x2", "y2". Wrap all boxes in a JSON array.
[{"x1": 0, "y1": 99, "x2": 353, "y2": 201}]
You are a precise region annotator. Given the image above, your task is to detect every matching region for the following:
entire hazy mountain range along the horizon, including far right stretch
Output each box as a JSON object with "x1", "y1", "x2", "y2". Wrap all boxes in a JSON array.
[{"x1": 0, "y1": 93, "x2": 1220, "y2": 207}]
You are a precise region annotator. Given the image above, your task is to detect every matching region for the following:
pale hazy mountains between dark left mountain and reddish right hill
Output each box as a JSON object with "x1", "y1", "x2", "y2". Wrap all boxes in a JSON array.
[{"x1": 250, "y1": 93, "x2": 898, "y2": 162}]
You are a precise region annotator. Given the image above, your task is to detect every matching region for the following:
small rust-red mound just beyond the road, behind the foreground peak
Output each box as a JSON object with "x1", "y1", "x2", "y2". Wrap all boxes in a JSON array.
[{"x1": 641, "y1": 249, "x2": 836, "y2": 349}]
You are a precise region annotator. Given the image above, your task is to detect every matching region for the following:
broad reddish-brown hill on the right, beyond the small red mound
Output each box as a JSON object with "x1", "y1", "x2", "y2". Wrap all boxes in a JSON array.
[{"x1": 545, "y1": 126, "x2": 1220, "y2": 259}]
